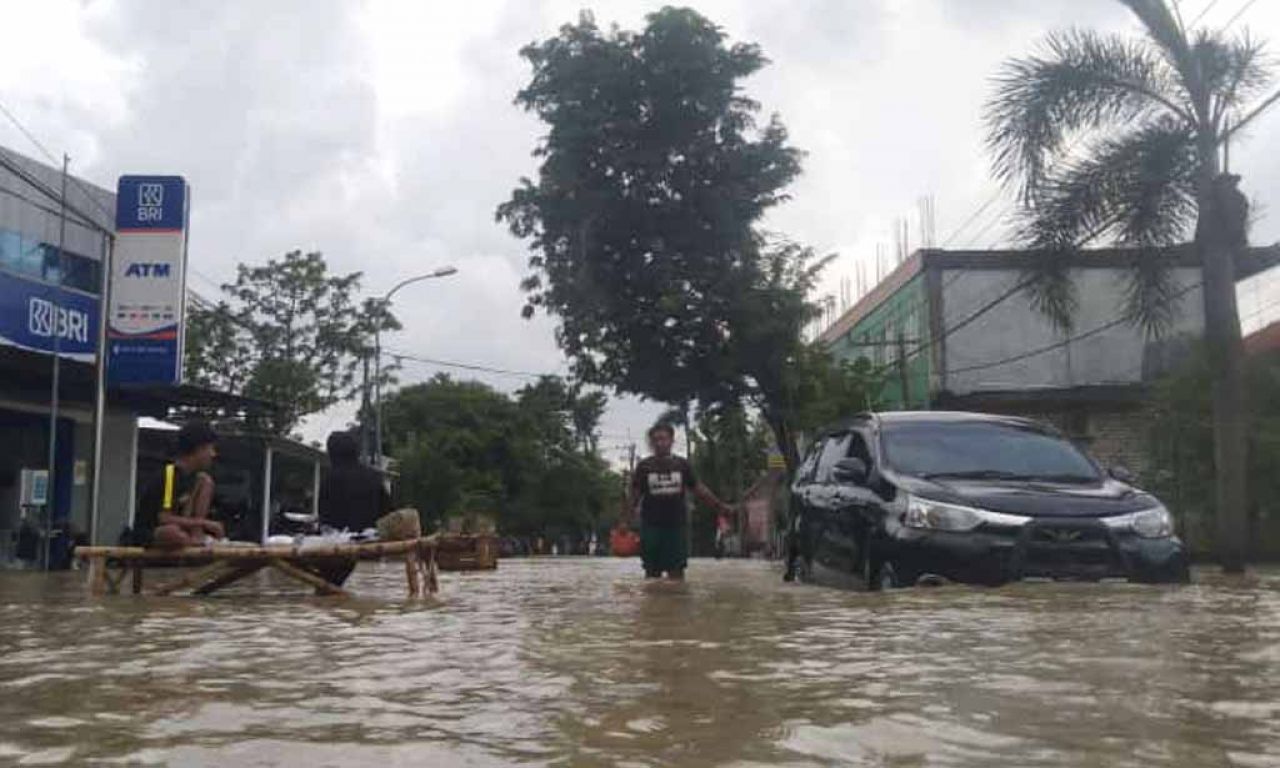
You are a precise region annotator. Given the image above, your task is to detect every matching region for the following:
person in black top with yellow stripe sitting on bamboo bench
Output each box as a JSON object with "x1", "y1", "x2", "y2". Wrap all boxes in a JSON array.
[{"x1": 134, "y1": 421, "x2": 225, "y2": 549}]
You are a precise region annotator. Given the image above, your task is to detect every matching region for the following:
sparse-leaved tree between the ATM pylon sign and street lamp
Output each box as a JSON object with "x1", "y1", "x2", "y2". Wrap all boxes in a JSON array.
[{"x1": 186, "y1": 251, "x2": 399, "y2": 434}]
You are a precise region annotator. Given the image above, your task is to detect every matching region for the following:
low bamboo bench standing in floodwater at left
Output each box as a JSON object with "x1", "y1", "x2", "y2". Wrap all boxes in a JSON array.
[{"x1": 76, "y1": 535, "x2": 449, "y2": 598}]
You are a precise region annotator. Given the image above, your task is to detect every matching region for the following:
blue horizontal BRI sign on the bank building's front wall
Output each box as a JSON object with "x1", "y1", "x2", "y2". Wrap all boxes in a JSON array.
[{"x1": 0, "y1": 271, "x2": 97, "y2": 362}]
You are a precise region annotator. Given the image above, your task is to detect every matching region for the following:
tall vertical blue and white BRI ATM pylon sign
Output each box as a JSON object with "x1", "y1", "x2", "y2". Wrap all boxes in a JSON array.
[{"x1": 106, "y1": 175, "x2": 191, "y2": 384}]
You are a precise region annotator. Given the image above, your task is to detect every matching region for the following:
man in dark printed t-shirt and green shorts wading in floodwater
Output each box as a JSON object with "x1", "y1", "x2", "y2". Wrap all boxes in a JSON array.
[{"x1": 627, "y1": 424, "x2": 733, "y2": 580}]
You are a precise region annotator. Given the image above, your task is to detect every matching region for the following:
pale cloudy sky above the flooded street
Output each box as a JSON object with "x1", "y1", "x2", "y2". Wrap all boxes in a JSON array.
[{"x1": 0, "y1": 0, "x2": 1280, "y2": 456}]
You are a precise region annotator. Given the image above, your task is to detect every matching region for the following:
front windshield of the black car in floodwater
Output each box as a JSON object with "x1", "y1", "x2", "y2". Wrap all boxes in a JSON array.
[{"x1": 882, "y1": 421, "x2": 1100, "y2": 483}]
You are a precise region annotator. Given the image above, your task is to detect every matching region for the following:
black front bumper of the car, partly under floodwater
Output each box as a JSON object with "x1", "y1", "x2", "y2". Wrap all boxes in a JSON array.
[{"x1": 887, "y1": 518, "x2": 1189, "y2": 584}]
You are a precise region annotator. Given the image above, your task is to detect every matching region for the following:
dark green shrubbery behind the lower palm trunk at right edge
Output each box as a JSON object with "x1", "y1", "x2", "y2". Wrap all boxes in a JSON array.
[{"x1": 1148, "y1": 349, "x2": 1280, "y2": 556}]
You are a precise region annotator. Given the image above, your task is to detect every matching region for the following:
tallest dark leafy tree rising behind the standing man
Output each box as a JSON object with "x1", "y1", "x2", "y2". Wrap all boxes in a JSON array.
[{"x1": 497, "y1": 8, "x2": 822, "y2": 467}]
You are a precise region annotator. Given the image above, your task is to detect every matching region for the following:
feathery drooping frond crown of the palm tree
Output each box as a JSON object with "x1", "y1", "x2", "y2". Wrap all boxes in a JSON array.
[{"x1": 987, "y1": 0, "x2": 1275, "y2": 335}]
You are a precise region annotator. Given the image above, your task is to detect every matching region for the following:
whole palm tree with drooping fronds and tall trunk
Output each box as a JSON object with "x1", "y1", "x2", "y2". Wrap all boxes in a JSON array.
[{"x1": 987, "y1": 0, "x2": 1280, "y2": 571}]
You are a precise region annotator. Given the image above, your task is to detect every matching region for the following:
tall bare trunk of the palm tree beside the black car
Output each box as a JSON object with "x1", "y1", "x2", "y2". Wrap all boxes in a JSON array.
[{"x1": 1196, "y1": 171, "x2": 1248, "y2": 573}]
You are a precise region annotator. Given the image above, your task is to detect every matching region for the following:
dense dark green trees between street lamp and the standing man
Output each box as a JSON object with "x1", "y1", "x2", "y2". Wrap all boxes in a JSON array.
[{"x1": 384, "y1": 375, "x2": 621, "y2": 534}]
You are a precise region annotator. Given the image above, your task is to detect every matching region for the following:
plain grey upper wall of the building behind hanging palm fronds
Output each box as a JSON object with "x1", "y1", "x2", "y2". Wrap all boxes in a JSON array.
[{"x1": 938, "y1": 268, "x2": 1203, "y2": 394}]
